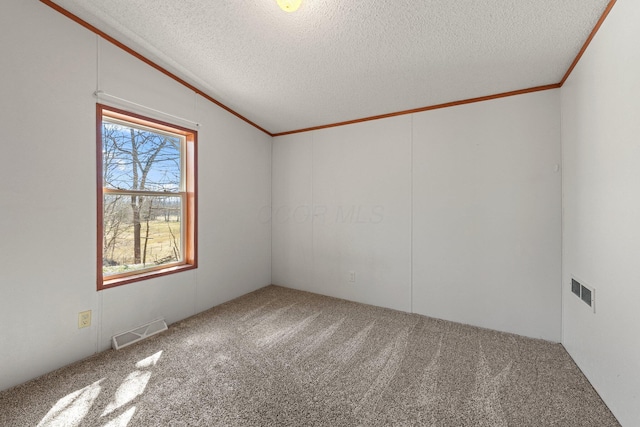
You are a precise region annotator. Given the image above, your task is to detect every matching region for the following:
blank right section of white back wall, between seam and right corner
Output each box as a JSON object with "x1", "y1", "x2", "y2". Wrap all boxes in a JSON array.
[{"x1": 413, "y1": 90, "x2": 561, "y2": 341}]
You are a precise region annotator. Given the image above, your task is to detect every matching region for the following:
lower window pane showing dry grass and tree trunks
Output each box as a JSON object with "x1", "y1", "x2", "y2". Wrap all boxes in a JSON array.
[{"x1": 102, "y1": 194, "x2": 183, "y2": 277}]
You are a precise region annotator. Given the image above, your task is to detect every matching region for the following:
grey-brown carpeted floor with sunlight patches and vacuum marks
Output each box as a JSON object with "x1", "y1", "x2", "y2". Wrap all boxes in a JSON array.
[{"x1": 0, "y1": 286, "x2": 619, "y2": 427}]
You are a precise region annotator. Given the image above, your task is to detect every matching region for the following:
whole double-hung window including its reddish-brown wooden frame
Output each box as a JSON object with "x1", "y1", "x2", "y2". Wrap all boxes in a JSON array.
[{"x1": 97, "y1": 104, "x2": 197, "y2": 290}]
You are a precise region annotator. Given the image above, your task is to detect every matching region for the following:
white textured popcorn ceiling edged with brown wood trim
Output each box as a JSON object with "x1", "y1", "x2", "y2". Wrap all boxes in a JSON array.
[{"x1": 48, "y1": 0, "x2": 608, "y2": 133}]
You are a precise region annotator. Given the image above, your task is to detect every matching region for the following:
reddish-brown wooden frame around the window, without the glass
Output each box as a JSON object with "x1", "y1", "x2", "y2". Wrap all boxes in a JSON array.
[{"x1": 96, "y1": 103, "x2": 198, "y2": 291}]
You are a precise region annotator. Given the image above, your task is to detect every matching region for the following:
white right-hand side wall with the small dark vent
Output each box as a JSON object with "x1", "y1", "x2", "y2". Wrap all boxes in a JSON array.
[{"x1": 562, "y1": 0, "x2": 640, "y2": 426}]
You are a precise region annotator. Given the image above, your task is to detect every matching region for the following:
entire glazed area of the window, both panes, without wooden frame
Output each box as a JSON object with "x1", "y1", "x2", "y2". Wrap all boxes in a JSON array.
[{"x1": 102, "y1": 120, "x2": 184, "y2": 275}]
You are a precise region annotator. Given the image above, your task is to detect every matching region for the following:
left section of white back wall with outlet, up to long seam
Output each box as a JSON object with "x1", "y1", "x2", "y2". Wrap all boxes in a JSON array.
[{"x1": 272, "y1": 116, "x2": 411, "y2": 311}]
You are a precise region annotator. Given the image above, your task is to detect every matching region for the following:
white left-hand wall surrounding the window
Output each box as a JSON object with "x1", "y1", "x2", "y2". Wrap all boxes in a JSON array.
[{"x1": 0, "y1": 0, "x2": 271, "y2": 390}]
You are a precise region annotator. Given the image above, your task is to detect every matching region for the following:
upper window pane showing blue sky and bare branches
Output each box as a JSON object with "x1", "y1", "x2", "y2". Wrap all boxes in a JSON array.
[{"x1": 102, "y1": 121, "x2": 184, "y2": 192}]
